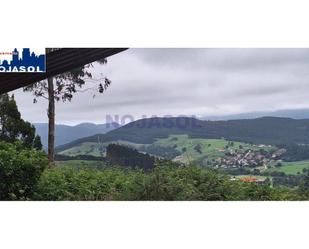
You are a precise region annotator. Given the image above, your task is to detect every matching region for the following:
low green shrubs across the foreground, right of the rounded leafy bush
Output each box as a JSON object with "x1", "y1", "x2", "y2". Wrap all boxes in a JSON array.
[{"x1": 34, "y1": 162, "x2": 300, "y2": 201}]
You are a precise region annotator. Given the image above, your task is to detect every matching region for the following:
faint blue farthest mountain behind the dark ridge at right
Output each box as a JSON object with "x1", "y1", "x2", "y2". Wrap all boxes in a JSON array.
[{"x1": 201, "y1": 109, "x2": 309, "y2": 121}]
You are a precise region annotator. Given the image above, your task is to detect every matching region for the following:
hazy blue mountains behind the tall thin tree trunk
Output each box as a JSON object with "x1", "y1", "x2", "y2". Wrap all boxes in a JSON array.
[{"x1": 34, "y1": 123, "x2": 119, "y2": 148}]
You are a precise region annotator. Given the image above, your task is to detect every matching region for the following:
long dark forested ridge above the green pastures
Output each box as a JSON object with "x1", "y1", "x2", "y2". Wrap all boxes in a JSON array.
[{"x1": 56, "y1": 117, "x2": 309, "y2": 152}]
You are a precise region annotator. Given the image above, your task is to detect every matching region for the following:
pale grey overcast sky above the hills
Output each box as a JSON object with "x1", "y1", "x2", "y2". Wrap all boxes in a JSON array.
[{"x1": 9, "y1": 48, "x2": 309, "y2": 124}]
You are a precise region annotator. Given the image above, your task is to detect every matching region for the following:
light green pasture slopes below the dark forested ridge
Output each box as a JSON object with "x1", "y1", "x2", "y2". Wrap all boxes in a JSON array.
[{"x1": 59, "y1": 135, "x2": 275, "y2": 162}]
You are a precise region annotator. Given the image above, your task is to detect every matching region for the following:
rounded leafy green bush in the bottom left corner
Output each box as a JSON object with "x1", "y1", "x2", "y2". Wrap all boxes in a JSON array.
[{"x1": 0, "y1": 142, "x2": 48, "y2": 200}]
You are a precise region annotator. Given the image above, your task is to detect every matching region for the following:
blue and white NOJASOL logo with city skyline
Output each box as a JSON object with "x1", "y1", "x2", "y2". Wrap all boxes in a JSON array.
[{"x1": 0, "y1": 48, "x2": 46, "y2": 73}]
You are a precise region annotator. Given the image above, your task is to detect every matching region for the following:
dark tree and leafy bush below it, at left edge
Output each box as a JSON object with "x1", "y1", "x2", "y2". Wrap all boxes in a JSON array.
[{"x1": 0, "y1": 94, "x2": 48, "y2": 200}]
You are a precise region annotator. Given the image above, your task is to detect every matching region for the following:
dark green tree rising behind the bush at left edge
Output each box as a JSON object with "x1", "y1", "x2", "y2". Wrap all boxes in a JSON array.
[{"x1": 0, "y1": 94, "x2": 42, "y2": 149}]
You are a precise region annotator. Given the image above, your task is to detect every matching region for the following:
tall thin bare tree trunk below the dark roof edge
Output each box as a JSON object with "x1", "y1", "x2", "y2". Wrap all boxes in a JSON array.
[{"x1": 47, "y1": 77, "x2": 55, "y2": 167}]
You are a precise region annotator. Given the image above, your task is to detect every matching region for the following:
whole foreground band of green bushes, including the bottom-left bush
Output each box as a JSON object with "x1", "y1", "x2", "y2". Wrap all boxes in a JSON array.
[{"x1": 0, "y1": 139, "x2": 309, "y2": 200}]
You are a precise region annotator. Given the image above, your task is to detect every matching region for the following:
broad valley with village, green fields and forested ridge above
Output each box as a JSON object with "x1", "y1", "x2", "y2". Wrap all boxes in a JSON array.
[{"x1": 53, "y1": 117, "x2": 309, "y2": 189}]
